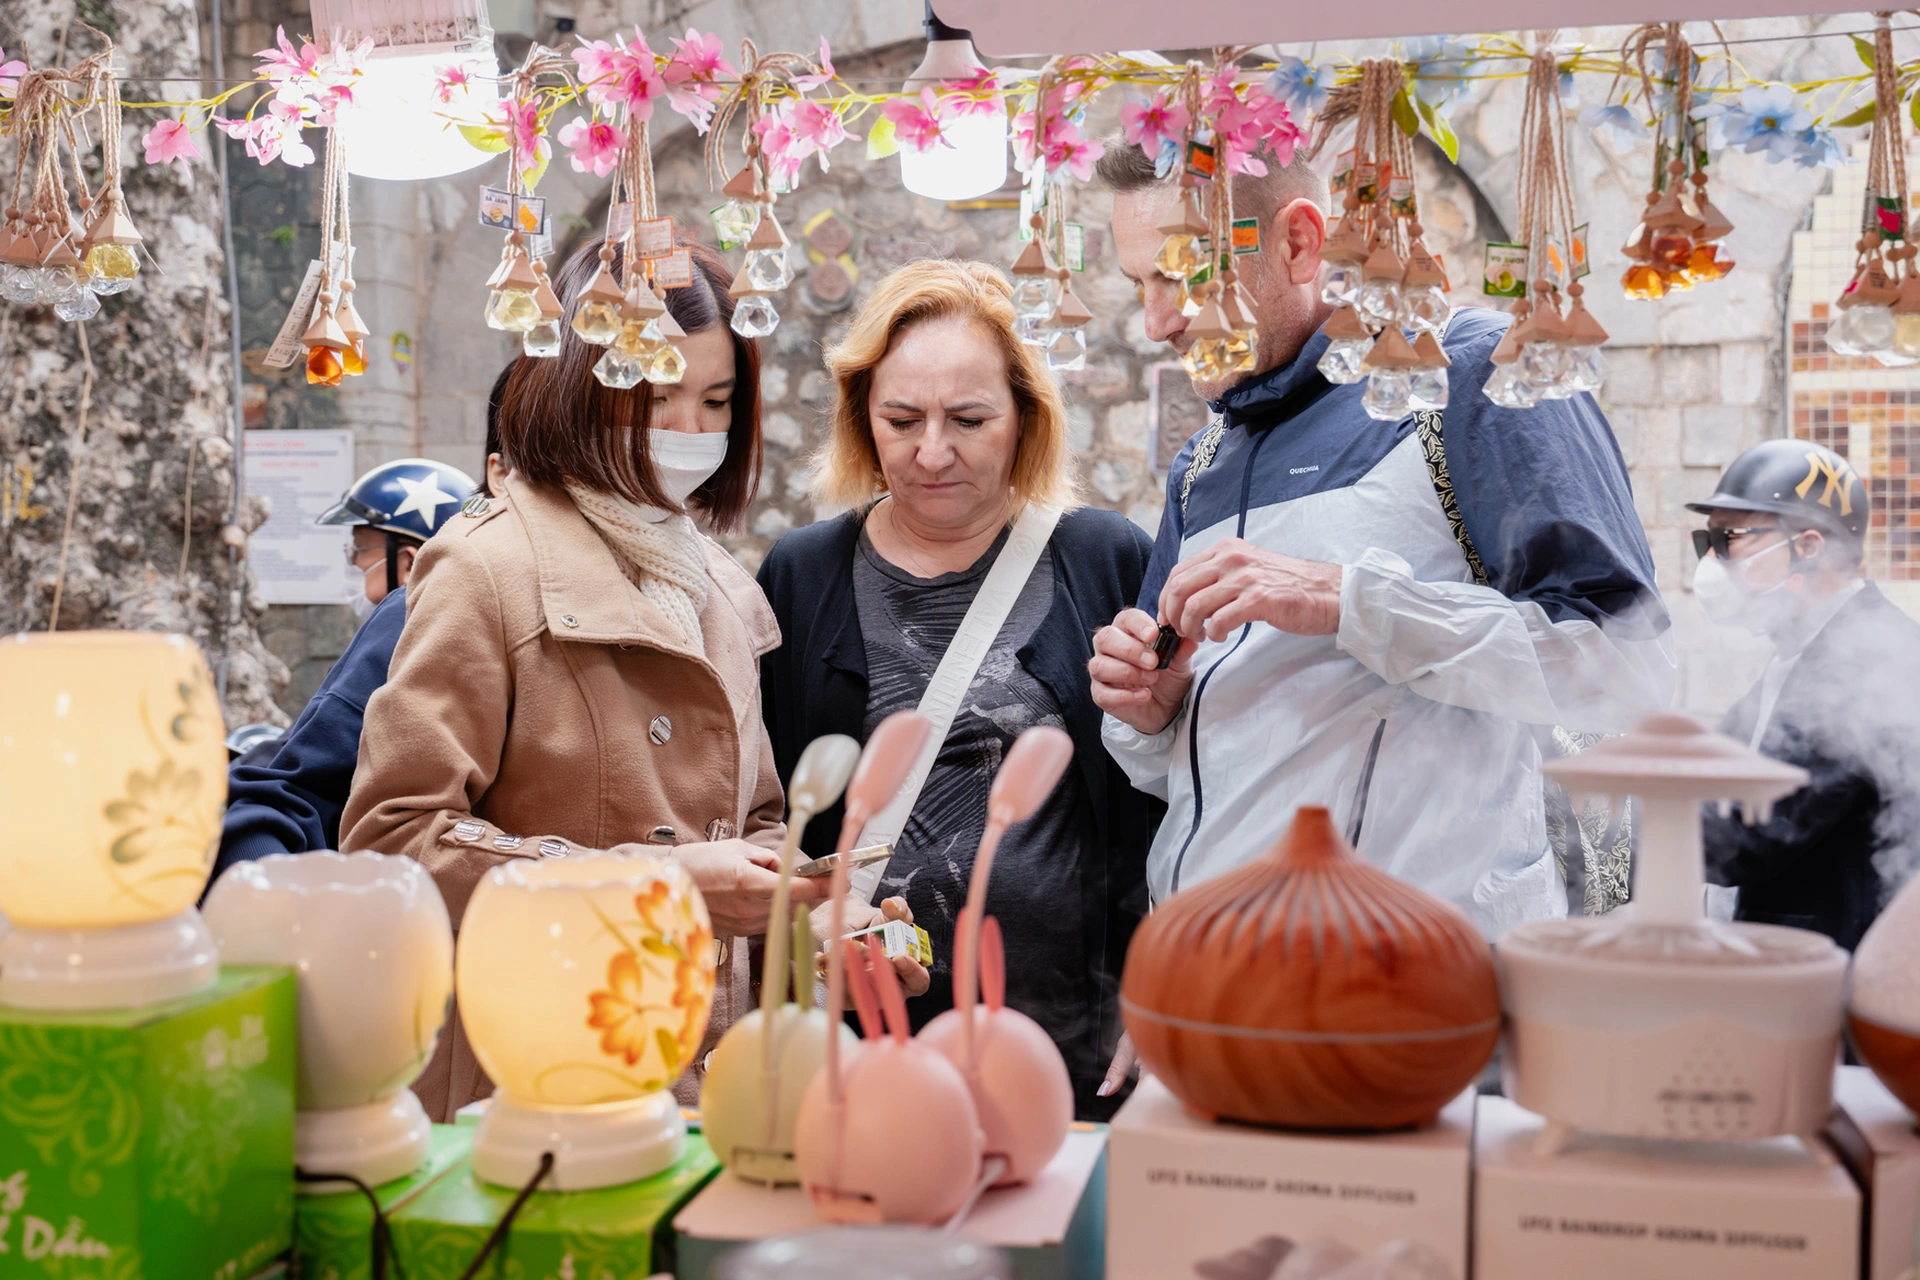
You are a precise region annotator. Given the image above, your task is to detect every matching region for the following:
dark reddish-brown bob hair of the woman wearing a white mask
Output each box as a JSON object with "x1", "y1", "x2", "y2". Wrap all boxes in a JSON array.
[{"x1": 497, "y1": 238, "x2": 760, "y2": 532}]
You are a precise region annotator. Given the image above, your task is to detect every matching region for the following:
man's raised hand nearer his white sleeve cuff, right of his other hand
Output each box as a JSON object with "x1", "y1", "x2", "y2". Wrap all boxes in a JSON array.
[{"x1": 1159, "y1": 537, "x2": 1342, "y2": 644}]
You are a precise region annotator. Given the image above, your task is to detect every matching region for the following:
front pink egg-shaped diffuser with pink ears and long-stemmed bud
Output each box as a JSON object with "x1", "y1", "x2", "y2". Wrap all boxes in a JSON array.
[{"x1": 793, "y1": 712, "x2": 985, "y2": 1222}]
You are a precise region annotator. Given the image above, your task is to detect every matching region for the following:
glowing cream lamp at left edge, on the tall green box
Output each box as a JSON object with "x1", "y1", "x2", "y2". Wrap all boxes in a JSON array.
[{"x1": 0, "y1": 631, "x2": 227, "y2": 1009}]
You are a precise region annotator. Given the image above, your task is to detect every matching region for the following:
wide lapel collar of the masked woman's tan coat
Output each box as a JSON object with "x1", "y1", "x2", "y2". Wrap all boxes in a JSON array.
[{"x1": 507, "y1": 474, "x2": 780, "y2": 660}]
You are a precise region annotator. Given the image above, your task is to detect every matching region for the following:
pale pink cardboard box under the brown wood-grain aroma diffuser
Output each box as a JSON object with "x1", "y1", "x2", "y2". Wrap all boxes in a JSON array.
[{"x1": 1106, "y1": 1077, "x2": 1473, "y2": 1280}]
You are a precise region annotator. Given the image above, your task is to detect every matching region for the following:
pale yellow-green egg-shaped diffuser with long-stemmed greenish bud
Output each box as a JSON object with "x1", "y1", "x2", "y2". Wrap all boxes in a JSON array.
[{"x1": 701, "y1": 733, "x2": 860, "y2": 1186}]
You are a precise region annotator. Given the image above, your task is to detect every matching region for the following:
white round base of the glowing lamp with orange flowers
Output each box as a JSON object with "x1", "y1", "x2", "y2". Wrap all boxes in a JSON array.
[{"x1": 474, "y1": 1090, "x2": 687, "y2": 1192}]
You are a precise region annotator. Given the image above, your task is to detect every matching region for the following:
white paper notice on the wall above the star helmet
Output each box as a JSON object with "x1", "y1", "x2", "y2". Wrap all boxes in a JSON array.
[{"x1": 246, "y1": 432, "x2": 353, "y2": 604}]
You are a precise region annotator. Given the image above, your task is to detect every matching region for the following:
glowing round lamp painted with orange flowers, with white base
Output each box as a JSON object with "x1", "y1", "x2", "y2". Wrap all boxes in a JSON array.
[{"x1": 453, "y1": 854, "x2": 714, "y2": 1192}]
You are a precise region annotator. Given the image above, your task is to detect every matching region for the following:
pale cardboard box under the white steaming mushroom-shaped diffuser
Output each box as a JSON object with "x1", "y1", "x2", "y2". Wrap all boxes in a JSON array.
[{"x1": 1473, "y1": 1098, "x2": 1860, "y2": 1280}]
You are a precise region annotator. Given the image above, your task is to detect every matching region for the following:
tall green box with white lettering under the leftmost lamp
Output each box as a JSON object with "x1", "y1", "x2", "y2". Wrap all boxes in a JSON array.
[{"x1": 0, "y1": 965, "x2": 296, "y2": 1280}]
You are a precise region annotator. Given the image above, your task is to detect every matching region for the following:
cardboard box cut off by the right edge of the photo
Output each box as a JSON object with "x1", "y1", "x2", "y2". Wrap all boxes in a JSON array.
[{"x1": 1826, "y1": 1067, "x2": 1920, "y2": 1280}]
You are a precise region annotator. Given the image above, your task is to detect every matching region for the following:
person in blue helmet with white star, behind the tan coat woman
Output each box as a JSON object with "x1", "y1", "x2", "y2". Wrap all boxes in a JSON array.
[{"x1": 213, "y1": 365, "x2": 511, "y2": 879}]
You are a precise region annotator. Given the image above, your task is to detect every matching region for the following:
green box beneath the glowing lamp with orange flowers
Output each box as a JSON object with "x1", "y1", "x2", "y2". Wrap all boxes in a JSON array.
[{"x1": 392, "y1": 1126, "x2": 720, "y2": 1280}]
